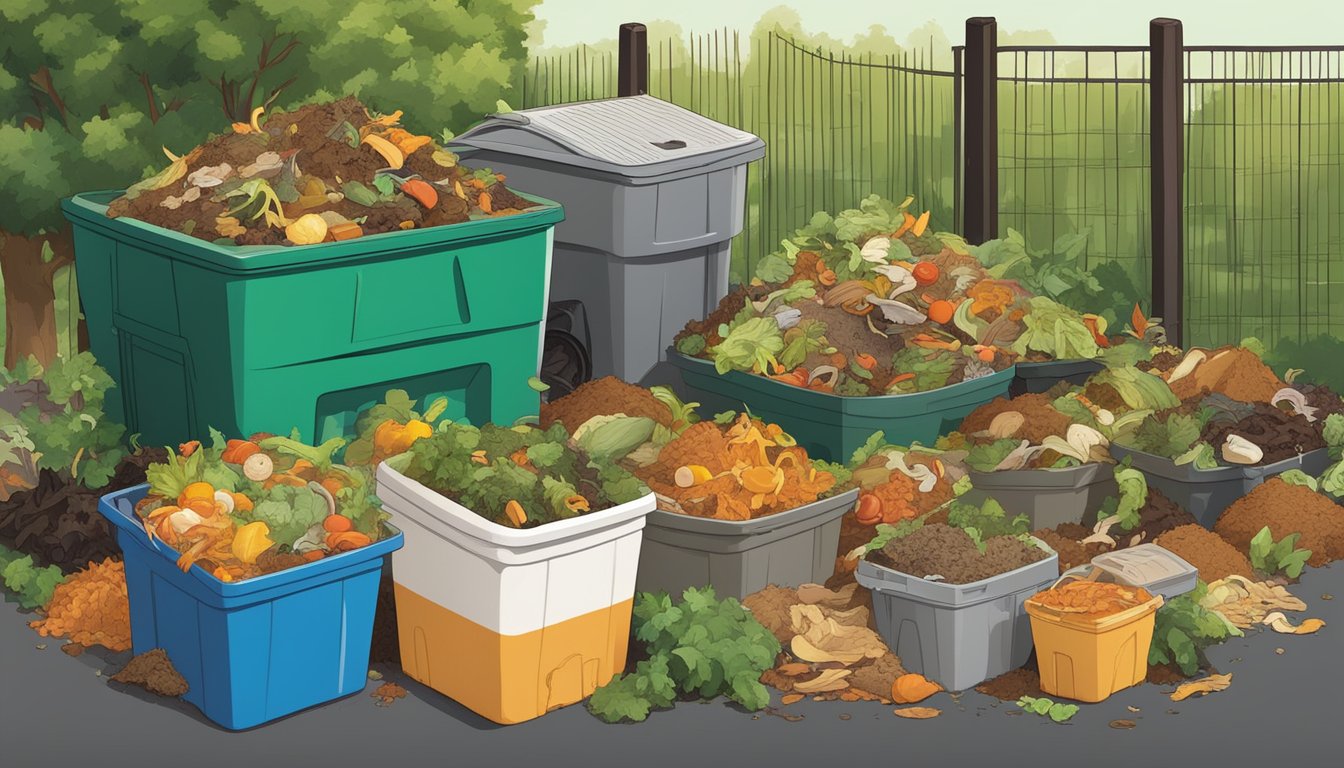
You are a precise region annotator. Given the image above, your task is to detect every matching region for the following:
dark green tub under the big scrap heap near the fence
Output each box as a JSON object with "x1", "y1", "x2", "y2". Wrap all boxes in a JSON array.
[{"x1": 668, "y1": 350, "x2": 1013, "y2": 461}]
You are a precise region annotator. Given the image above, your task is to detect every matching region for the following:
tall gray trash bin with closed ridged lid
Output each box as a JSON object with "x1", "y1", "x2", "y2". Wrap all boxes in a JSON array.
[{"x1": 454, "y1": 95, "x2": 765, "y2": 385}]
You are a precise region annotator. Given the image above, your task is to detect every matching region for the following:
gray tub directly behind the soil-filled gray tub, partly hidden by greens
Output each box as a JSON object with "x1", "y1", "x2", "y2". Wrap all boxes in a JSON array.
[{"x1": 968, "y1": 464, "x2": 1117, "y2": 530}]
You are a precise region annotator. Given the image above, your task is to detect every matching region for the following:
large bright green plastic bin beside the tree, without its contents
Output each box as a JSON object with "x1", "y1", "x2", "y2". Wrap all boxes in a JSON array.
[{"x1": 62, "y1": 191, "x2": 564, "y2": 445}]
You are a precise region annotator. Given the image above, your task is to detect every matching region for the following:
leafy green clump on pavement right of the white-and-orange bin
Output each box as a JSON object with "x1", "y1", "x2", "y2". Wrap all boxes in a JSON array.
[{"x1": 587, "y1": 586, "x2": 780, "y2": 722}]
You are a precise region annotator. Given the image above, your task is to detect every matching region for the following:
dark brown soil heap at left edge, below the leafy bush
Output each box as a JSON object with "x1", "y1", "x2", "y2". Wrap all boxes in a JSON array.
[{"x1": 0, "y1": 448, "x2": 167, "y2": 573}]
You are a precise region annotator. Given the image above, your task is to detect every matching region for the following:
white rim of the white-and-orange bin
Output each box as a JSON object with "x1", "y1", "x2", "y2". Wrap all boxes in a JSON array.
[{"x1": 378, "y1": 461, "x2": 657, "y2": 550}]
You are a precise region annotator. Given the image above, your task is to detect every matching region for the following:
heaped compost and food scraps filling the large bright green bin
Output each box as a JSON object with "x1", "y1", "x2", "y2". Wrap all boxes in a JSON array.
[{"x1": 108, "y1": 97, "x2": 532, "y2": 245}]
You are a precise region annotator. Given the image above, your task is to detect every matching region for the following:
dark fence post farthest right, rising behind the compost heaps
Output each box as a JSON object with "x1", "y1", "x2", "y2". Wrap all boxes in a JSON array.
[{"x1": 1148, "y1": 19, "x2": 1185, "y2": 347}]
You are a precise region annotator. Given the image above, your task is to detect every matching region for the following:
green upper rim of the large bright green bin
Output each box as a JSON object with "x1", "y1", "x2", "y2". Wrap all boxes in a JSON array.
[{"x1": 60, "y1": 190, "x2": 564, "y2": 274}]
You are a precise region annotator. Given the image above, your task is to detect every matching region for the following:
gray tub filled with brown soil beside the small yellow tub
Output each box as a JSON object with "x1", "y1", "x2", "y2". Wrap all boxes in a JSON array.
[{"x1": 855, "y1": 539, "x2": 1059, "y2": 691}]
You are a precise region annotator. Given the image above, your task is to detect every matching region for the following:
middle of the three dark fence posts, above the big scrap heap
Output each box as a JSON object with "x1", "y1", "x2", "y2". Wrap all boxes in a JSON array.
[{"x1": 962, "y1": 16, "x2": 999, "y2": 243}]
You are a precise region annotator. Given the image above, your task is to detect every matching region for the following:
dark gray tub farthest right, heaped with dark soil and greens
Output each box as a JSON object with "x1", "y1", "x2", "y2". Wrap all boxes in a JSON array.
[{"x1": 1110, "y1": 444, "x2": 1331, "y2": 529}]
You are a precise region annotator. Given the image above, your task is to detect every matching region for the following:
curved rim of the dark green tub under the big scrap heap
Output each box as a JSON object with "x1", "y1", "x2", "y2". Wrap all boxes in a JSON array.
[{"x1": 668, "y1": 347, "x2": 1016, "y2": 418}]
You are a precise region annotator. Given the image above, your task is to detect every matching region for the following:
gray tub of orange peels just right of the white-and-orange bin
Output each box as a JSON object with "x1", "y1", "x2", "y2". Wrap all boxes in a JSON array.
[{"x1": 634, "y1": 488, "x2": 859, "y2": 600}]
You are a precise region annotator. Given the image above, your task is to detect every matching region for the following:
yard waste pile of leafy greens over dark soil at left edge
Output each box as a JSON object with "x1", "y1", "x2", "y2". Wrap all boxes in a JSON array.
[{"x1": 0, "y1": 352, "x2": 163, "y2": 573}]
